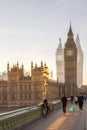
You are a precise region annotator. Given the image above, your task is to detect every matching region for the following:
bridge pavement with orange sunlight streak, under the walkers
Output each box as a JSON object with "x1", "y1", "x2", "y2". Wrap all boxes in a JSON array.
[{"x1": 22, "y1": 103, "x2": 87, "y2": 130}]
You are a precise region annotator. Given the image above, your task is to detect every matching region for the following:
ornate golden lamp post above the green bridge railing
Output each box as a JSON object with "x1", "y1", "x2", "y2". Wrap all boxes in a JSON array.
[{"x1": 43, "y1": 64, "x2": 49, "y2": 99}]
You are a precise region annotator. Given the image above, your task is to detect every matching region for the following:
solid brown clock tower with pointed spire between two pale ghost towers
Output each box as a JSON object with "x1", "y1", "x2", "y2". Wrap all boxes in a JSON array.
[{"x1": 64, "y1": 24, "x2": 77, "y2": 88}]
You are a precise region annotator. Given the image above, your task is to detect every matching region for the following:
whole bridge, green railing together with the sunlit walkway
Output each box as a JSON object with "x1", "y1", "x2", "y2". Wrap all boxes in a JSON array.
[{"x1": 0, "y1": 100, "x2": 87, "y2": 130}]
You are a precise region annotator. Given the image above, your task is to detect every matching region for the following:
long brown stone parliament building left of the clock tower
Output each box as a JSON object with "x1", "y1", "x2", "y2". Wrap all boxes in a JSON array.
[{"x1": 0, "y1": 62, "x2": 59, "y2": 108}]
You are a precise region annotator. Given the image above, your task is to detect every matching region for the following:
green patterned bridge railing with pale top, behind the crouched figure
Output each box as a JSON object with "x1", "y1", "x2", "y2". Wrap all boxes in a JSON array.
[{"x1": 0, "y1": 100, "x2": 67, "y2": 130}]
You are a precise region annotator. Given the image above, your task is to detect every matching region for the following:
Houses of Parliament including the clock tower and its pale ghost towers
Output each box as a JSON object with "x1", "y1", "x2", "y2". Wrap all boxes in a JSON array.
[{"x1": 0, "y1": 25, "x2": 83, "y2": 108}]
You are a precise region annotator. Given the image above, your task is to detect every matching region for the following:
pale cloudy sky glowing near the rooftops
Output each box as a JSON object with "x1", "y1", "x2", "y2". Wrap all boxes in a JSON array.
[{"x1": 0, "y1": 0, "x2": 87, "y2": 84}]
